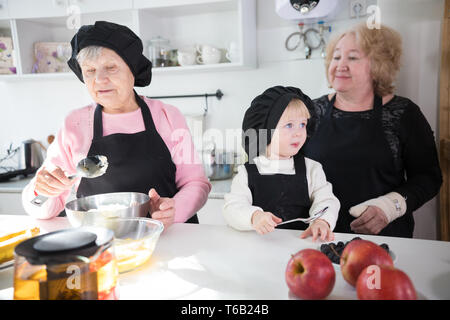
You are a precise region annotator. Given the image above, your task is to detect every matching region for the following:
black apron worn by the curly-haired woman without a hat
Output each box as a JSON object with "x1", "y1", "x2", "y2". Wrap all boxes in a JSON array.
[{"x1": 302, "y1": 95, "x2": 414, "y2": 237}]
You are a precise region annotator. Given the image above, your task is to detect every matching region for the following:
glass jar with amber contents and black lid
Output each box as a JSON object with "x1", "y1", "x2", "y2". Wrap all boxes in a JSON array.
[{"x1": 14, "y1": 227, "x2": 119, "y2": 300}]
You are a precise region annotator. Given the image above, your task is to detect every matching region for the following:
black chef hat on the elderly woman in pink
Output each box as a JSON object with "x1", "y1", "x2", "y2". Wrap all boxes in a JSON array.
[{"x1": 67, "y1": 21, "x2": 152, "y2": 87}]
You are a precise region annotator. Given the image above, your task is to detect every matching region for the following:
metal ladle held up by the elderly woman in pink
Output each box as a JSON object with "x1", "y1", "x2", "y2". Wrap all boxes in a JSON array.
[{"x1": 31, "y1": 155, "x2": 108, "y2": 207}]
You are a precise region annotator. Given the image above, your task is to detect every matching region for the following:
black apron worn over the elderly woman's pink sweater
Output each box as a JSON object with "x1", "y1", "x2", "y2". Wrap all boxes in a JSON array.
[{"x1": 77, "y1": 92, "x2": 198, "y2": 223}]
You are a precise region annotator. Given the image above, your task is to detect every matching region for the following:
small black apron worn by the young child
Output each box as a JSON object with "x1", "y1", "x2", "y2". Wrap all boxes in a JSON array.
[{"x1": 245, "y1": 154, "x2": 311, "y2": 230}]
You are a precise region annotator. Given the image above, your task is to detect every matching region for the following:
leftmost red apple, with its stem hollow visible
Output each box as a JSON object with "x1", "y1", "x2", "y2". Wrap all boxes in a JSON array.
[{"x1": 285, "y1": 249, "x2": 336, "y2": 299}]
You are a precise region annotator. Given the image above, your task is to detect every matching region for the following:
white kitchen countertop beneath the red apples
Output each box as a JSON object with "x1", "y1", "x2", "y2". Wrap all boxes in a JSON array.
[{"x1": 0, "y1": 216, "x2": 450, "y2": 300}]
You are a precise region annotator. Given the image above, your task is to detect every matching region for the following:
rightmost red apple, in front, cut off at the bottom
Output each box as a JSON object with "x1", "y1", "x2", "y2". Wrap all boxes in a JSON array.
[{"x1": 356, "y1": 265, "x2": 417, "y2": 300}]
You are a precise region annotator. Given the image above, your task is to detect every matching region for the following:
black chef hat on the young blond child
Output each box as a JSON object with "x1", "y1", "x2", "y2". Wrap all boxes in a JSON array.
[{"x1": 242, "y1": 86, "x2": 314, "y2": 161}]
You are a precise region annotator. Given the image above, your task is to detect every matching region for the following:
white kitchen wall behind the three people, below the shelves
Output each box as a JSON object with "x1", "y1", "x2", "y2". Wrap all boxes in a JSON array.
[{"x1": 0, "y1": 0, "x2": 444, "y2": 239}]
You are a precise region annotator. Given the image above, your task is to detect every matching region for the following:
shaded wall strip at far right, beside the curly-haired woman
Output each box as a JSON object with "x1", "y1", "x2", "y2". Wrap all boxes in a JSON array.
[{"x1": 378, "y1": 0, "x2": 444, "y2": 239}]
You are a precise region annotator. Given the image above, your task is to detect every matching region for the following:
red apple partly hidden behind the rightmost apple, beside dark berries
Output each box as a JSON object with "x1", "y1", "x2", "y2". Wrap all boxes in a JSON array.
[{"x1": 341, "y1": 240, "x2": 394, "y2": 286}]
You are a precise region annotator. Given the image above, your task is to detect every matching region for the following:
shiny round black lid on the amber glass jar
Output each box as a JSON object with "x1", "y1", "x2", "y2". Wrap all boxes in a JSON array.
[{"x1": 14, "y1": 227, "x2": 114, "y2": 265}]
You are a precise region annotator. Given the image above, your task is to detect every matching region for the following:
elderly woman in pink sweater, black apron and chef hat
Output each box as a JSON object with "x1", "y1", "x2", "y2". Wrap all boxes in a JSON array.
[{"x1": 22, "y1": 21, "x2": 211, "y2": 228}]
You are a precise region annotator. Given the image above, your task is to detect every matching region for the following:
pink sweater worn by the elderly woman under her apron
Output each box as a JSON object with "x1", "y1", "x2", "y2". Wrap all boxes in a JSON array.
[{"x1": 22, "y1": 97, "x2": 211, "y2": 222}]
